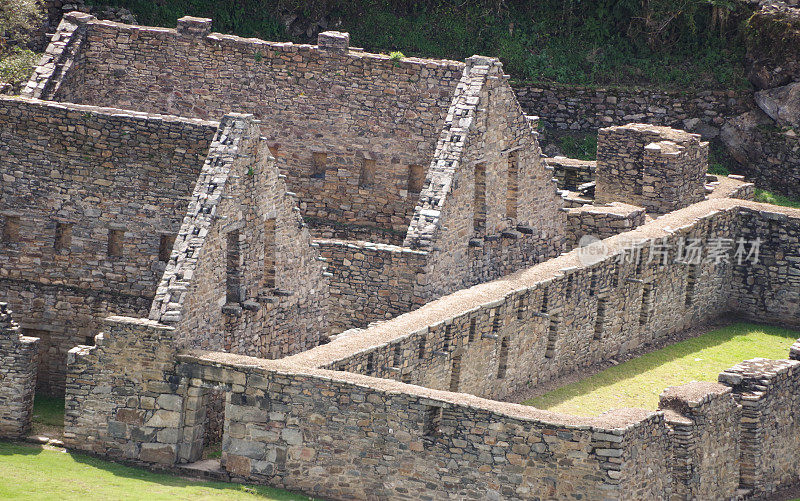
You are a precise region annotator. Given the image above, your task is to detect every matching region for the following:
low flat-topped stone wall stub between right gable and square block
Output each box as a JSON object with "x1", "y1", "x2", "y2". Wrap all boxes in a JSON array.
[{"x1": 566, "y1": 202, "x2": 646, "y2": 250}]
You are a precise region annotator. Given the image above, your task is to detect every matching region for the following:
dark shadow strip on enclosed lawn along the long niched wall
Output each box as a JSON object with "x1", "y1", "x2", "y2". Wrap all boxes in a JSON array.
[{"x1": 523, "y1": 322, "x2": 800, "y2": 408}]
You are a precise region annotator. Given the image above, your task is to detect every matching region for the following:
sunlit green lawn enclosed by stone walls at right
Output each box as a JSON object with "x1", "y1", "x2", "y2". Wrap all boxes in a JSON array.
[{"x1": 524, "y1": 323, "x2": 800, "y2": 416}]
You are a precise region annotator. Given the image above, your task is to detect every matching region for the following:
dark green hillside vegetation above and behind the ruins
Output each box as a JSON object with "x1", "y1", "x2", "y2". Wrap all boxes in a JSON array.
[{"x1": 93, "y1": 0, "x2": 751, "y2": 90}]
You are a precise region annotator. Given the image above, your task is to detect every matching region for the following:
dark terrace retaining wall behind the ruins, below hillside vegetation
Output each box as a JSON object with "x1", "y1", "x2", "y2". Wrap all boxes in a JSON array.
[{"x1": 512, "y1": 82, "x2": 754, "y2": 135}]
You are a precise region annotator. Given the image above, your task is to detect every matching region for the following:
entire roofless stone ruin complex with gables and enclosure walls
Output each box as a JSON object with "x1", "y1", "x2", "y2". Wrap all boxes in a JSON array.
[{"x1": 0, "y1": 13, "x2": 800, "y2": 499}]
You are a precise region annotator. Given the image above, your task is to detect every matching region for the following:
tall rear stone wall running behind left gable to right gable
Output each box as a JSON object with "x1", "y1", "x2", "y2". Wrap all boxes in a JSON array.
[{"x1": 26, "y1": 16, "x2": 463, "y2": 238}]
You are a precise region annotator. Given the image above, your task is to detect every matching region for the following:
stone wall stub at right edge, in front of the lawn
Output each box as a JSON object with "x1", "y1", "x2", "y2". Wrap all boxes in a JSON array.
[{"x1": 719, "y1": 358, "x2": 800, "y2": 496}]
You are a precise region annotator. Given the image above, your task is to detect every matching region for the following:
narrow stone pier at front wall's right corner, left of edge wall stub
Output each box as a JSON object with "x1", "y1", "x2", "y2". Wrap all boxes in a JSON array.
[{"x1": 658, "y1": 382, "x2": 742, "y2": 499}]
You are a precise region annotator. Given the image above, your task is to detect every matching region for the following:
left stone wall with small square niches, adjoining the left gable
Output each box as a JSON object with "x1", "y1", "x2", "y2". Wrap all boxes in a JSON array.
[{"x1": 0, "y1": 97, "x2": 216, "y2": 393}]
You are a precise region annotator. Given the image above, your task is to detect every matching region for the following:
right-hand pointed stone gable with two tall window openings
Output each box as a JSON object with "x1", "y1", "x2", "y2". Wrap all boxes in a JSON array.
[{"x1": 403, "y1": 56, "x2": 565, "y2": 298}]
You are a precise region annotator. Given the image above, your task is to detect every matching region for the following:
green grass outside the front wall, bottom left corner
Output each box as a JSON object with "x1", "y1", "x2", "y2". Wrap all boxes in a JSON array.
[{"x1": 0, "y1": 442, "x2": 311, "y2": 501}]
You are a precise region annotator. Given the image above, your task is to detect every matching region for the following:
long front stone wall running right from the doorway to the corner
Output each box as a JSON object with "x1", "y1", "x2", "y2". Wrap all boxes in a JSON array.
[{"x1": 180, "y1": 353, "x2": 669, "y2": 499}]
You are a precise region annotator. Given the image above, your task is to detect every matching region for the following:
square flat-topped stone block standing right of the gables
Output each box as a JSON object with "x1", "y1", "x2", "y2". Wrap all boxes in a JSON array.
[{"x1": 595, "y1": 124, "x2": 708, "y2": 214}]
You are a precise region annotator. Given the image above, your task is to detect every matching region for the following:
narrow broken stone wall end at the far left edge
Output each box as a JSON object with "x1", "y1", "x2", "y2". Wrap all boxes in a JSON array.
[{"x1": 0, "y1": 303, "x2": 39, "y2": 438}]
